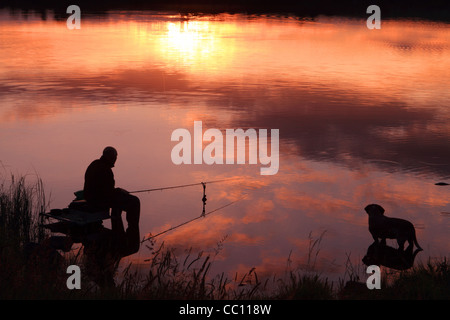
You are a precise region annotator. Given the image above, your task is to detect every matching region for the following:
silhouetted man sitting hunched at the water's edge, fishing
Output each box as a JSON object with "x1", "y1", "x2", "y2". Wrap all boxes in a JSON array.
[{"x1": 84, "y1": 147, "x2": 141, "y2": 256}]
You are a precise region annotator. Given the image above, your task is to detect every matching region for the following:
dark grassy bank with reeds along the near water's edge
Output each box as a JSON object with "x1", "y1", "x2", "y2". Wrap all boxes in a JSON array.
[{"x1": 0, "y1": 176, "x2": 450, "y2": 300}]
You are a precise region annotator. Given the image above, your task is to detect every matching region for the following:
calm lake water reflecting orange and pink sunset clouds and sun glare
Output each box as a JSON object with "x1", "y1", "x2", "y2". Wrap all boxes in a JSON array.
[{"x1": 0, "y1": 11, "x2": 450, "y2": 277}]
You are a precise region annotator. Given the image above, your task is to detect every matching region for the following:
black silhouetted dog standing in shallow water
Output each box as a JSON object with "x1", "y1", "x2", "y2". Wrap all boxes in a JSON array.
[{"x1": 364, "y1": 204, "x2": 422, "y2": 250}]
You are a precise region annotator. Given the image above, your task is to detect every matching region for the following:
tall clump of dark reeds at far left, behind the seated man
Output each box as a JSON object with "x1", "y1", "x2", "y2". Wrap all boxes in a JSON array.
[{"x1": 0, "y1": 174, "x2": 53, "y2": 298}]
